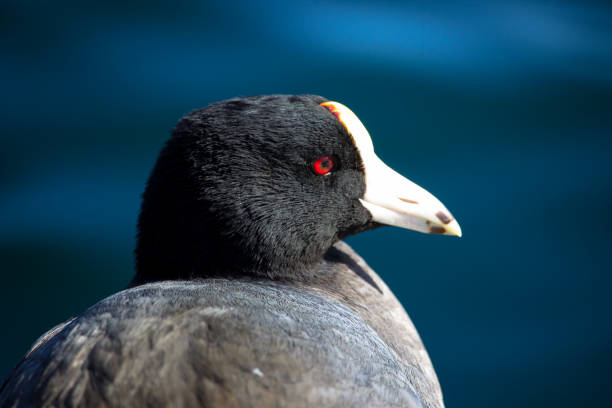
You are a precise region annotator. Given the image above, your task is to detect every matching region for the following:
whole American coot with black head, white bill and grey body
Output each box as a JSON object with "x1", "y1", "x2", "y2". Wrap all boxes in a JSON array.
[{"x1": 0, "y1": 95, "x2": 461, "y2": 407}]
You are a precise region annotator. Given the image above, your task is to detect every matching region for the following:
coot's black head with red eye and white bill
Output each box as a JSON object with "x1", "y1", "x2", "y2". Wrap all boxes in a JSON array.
[{"x1": 133, "y1": 95, "x2": 461, "y2": 284}]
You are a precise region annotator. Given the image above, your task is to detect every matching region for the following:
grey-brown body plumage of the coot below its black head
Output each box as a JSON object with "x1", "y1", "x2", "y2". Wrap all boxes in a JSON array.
[{"x1": 0, "y1": 242, "x2": 443, "y2": 408}]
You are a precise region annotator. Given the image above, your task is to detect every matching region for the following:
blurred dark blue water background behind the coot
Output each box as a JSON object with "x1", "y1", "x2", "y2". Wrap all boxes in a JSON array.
[{"x1": 0, "y1": 0, "x2": 612, "y2": 407}]
